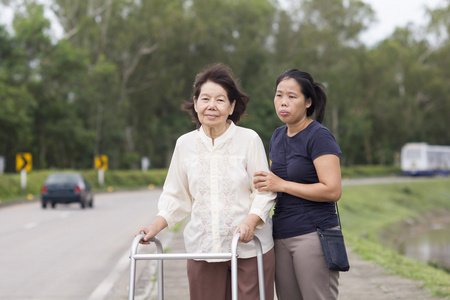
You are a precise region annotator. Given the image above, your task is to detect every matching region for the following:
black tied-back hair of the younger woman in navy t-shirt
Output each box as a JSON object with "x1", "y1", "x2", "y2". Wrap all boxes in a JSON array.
[{"x1": 275, "y1": 69, "x2": 327, "y2": 123}]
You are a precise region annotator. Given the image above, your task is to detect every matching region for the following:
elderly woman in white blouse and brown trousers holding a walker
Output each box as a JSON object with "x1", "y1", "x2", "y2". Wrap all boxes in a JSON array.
[{"x1": 138, "y1": 64, "x2": 276, "y2": 300}]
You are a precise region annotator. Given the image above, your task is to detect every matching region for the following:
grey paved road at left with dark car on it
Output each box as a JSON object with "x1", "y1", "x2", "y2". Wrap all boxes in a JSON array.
[{"x1": 0, "y1": 190, "x2": 161, "y2": 300}]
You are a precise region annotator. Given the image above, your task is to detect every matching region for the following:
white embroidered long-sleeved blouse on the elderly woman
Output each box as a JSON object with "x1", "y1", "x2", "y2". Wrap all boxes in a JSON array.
[{"x1": 158, "y1": 123, "x2": 276, "y2": 261}]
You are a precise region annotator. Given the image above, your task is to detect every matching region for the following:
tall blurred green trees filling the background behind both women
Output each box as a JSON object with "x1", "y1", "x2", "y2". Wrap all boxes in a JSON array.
[{"x1": 0, "y1": 0, "x2": 450, "y2": 172}]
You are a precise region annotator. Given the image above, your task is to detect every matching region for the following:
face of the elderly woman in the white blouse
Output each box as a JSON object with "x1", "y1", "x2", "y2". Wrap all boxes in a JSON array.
[{"x1": 194, "y1": 81, "x2": 236, "y2": 128}]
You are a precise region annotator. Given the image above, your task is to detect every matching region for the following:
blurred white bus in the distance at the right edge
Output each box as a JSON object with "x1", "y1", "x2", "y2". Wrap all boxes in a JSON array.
[{"x1": 401, "y1": 143, "x2": 450, "y2": 175}]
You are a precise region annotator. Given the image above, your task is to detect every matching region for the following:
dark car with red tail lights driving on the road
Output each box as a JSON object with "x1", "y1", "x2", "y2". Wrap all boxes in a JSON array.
[{"x1": 41, "y1": 172, "x2": 94, "y2": 208}]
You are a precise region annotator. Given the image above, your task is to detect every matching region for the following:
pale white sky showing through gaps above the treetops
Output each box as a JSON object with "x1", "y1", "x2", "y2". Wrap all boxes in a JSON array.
[{"x1": 0, "y1": 0, "x2": 447, "y2": 45}]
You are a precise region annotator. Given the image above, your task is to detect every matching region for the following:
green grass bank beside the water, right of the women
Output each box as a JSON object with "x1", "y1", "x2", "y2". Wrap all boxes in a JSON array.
[{"x1": 339, "y1": 178, "x2": 450, "y2": 299}]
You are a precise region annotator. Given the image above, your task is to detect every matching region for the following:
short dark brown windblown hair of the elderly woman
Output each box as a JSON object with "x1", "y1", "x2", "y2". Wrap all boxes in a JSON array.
[{"x1": 182, "y1": 63, "x2": 250, "y2": 129}]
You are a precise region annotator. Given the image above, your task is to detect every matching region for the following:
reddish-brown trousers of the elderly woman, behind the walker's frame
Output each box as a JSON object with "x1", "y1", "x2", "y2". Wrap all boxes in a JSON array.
[{"x1": 187, "y1": 248, "x2": 275, "y2": 300}]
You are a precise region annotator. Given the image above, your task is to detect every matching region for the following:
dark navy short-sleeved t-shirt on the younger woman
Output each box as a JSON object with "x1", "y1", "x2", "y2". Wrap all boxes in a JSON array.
[{"x1": 270, "y1": 121, "x2": 341, "y2": 239}]
